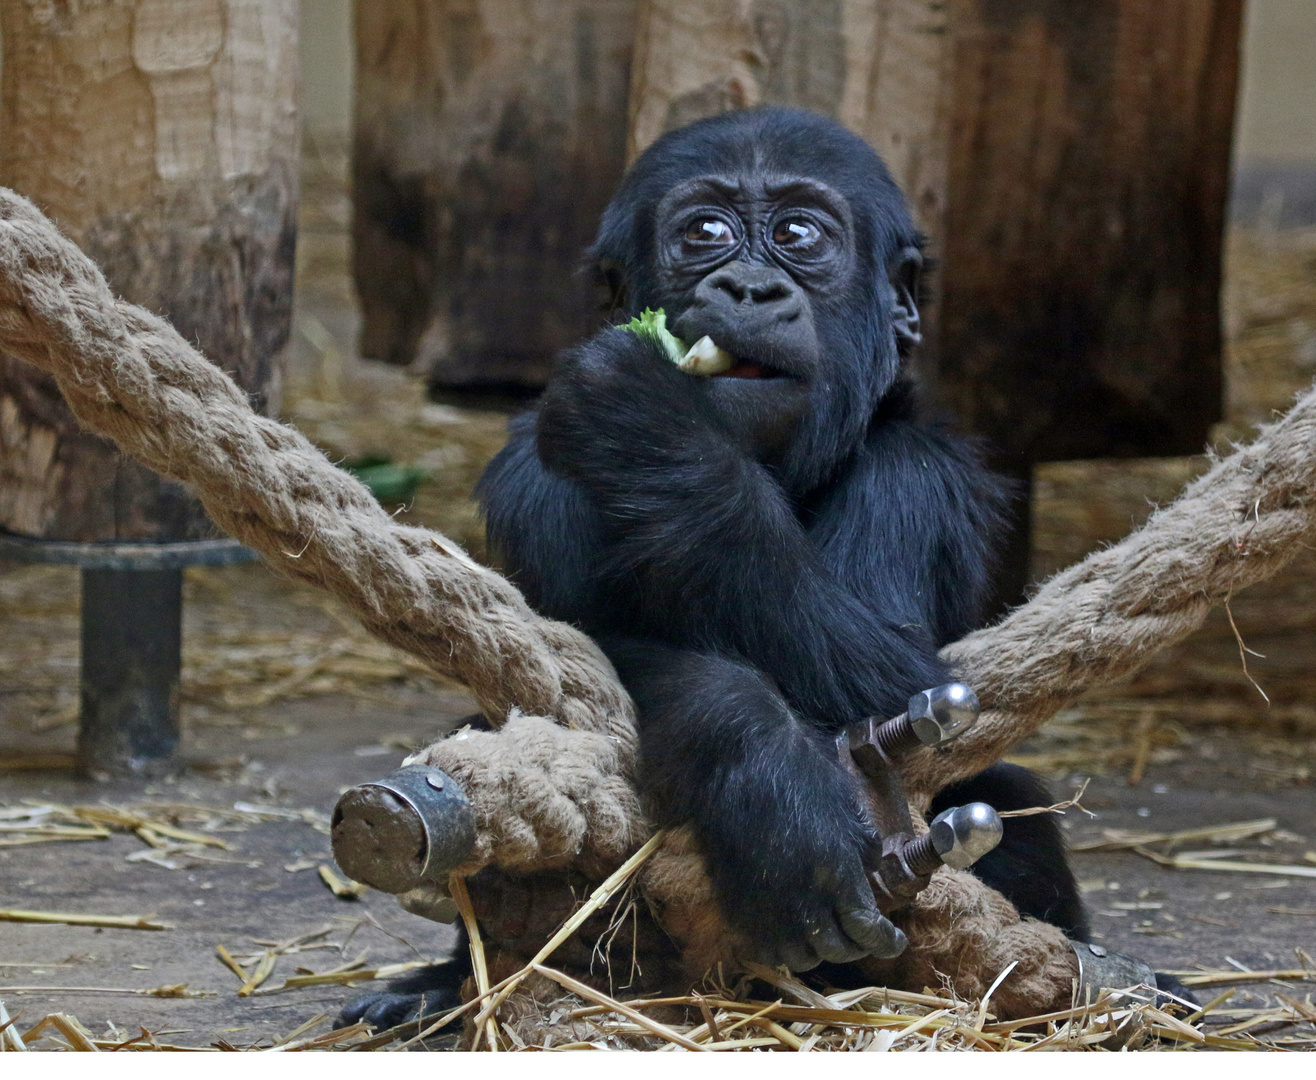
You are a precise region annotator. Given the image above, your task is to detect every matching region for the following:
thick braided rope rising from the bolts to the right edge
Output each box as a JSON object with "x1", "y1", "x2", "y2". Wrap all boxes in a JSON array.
[{"x1": 903, "y1": 389, "x2": 1316, "y2": 797}]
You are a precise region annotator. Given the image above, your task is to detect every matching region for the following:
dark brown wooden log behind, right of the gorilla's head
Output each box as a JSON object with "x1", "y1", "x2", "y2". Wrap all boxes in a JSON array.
[{"x1": 940, "y1": 0, "x2": 1242, "y2": 470}]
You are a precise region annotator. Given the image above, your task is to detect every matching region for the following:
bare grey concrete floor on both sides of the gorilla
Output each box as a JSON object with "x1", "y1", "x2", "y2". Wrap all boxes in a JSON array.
[{"x1": 0, "y1": 691, "x2": 1316, "y2": 1046}]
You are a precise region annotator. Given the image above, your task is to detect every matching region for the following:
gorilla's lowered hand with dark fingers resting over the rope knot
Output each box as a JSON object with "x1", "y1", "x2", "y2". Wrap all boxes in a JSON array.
[{"x1": 709, "y1": 820, "x2": 905, "y2": 971}]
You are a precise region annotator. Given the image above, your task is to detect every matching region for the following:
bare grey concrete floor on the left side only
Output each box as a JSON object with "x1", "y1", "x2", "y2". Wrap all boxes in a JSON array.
[{"x1": 0, "y1": 693, "x2": 471, "y2": 1046}]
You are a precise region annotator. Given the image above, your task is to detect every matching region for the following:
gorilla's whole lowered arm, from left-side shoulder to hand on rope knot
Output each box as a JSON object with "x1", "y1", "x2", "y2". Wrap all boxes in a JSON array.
[{"x1": 479, "y1": 360, "x2": 901, "y2": 970}]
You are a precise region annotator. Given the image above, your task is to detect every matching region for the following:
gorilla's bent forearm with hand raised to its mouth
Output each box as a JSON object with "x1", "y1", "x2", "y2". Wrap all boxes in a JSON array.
[{"x1": 538, "y1": 330, "x2": 946, "y2": 726}]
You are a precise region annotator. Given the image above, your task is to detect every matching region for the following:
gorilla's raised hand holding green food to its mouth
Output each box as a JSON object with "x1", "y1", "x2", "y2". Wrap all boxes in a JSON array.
[{"x1": 536, "y1": 329, "x2": 733, "y2": 484}]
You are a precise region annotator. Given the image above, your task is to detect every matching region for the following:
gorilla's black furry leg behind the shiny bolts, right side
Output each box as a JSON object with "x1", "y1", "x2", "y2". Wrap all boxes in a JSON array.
[{"x1": 930, "y1": 762, "x2": 1091, "y2": 942}]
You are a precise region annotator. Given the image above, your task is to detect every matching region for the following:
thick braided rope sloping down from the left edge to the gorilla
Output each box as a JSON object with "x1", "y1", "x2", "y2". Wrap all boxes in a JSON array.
[{"x1": 0, "y1": 188, "x2": 636, "y2": 752}]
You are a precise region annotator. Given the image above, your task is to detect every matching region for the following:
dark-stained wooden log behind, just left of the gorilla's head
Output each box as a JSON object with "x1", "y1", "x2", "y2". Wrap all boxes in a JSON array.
[{"x1": 353, "y1": 0, "x2": 636, "y2": 389}]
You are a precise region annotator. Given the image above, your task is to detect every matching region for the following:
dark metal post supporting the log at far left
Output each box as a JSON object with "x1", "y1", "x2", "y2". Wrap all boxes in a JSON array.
[{"x1": 78, "y1": 570, "x2": 183, "y2": 779}]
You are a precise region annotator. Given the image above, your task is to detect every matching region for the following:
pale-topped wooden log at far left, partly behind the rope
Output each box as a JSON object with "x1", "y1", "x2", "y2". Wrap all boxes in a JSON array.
[{"x1": 0, "y1": 0, "x2": 297, "y2": 541}]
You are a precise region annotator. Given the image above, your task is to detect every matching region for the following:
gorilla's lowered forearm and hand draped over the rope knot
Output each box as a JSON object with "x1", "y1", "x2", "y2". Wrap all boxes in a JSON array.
[{"x1": 604, "y1": 638, "x2": 904, "y2": 971}]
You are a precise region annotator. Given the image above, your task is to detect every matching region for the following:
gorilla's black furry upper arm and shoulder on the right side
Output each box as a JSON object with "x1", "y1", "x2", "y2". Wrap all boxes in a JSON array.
[{"x1": 809, "y1": 388, "x2": 1009, "y2": 646}]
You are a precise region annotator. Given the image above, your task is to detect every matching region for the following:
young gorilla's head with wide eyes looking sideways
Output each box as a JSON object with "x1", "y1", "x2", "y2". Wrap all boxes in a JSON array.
[{"x1": 594, "y1": 108, "x2": 923, "y2": 491}]
